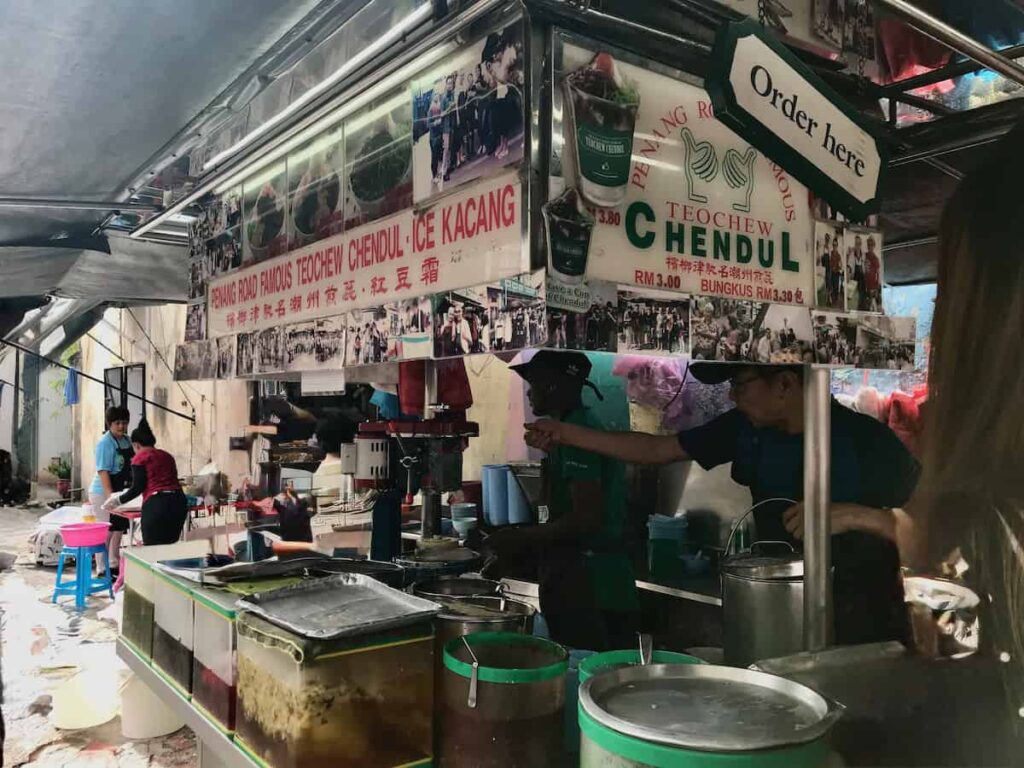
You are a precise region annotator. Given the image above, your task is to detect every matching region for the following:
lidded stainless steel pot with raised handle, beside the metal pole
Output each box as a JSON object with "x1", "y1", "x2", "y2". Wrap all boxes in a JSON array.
[{"x1": 722, "y1": 545, "x2": 804, "y2": 667}]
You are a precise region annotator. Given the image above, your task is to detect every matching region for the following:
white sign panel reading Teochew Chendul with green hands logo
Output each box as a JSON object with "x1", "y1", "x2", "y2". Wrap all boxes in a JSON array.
[{"x1": 562, "y1": 44, "x2": 814, "y2": 304}]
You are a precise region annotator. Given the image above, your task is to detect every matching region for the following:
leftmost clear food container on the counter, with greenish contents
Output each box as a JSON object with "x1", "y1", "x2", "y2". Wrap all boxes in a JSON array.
[{"x1": 121, "y1": 541, "x2": 210, "y2": 662}]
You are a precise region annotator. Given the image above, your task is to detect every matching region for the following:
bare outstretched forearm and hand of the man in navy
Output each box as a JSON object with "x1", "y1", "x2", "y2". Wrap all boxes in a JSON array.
[{"x1": 524, "y1": 419, "x2": 689, "y2": 464}]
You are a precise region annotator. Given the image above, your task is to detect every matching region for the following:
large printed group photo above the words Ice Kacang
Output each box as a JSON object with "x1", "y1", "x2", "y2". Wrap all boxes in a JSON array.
[{"x1": 413, "y1": 22, "x2": 524, "y2": 202}]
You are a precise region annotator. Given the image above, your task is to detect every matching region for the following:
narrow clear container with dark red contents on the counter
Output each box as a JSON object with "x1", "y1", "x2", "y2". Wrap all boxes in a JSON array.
[{"x1": 193, "y1": 587, "x2": 239, "y2": 733}]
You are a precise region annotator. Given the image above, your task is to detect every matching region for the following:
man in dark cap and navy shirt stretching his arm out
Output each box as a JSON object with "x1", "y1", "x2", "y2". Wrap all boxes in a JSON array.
[{"x1": 526, "y1": 362, "x2": 919, "y2": 644}]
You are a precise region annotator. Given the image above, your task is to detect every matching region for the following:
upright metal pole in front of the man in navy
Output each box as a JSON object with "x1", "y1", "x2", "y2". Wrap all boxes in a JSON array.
[{"x1": 804, "y1": 368, "x2": 833, "y2": 651}]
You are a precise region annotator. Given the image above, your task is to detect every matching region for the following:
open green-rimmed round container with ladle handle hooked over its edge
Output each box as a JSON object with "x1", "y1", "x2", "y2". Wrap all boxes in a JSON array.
[{"x1": 437, "y1": 632, "x2": 568, "y2": 768}]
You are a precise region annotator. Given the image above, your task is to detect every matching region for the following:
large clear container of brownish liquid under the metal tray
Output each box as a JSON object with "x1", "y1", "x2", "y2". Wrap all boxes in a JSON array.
[{"x1": 234, "y1": 612, "x2": 434, "y2": 768}]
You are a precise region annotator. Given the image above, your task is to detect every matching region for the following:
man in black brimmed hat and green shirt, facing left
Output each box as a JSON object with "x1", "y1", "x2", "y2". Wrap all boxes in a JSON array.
[{"x1": 485, "y1": 349, "x2": 639, "y2": 650}]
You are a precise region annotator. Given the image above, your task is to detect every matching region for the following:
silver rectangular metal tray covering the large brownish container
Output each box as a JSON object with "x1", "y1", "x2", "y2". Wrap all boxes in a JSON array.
[{"x1": 239, "y1": 573, "x2": 441, "y2": 640}]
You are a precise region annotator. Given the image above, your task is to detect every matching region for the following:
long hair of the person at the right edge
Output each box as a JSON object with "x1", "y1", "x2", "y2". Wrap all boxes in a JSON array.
[{"x1": 911, "y1": 126, "x2": 1024, "y2": 716}]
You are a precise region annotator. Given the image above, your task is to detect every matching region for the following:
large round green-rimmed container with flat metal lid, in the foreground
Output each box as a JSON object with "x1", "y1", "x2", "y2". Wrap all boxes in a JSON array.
[{"x1": 580, "y1": 665, "x2": 843, "y2": 768}]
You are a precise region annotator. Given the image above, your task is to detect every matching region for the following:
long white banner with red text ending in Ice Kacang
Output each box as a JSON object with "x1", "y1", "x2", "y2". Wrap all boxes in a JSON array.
[{"x1": 207, "y1": 172, "x2": 528, "y2": 337}]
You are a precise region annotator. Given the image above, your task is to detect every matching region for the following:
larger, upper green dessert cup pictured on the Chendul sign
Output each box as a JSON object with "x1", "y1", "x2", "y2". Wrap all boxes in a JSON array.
[{"x1": 563, "y1": 53, "x2": 640, "y2": 208}]
